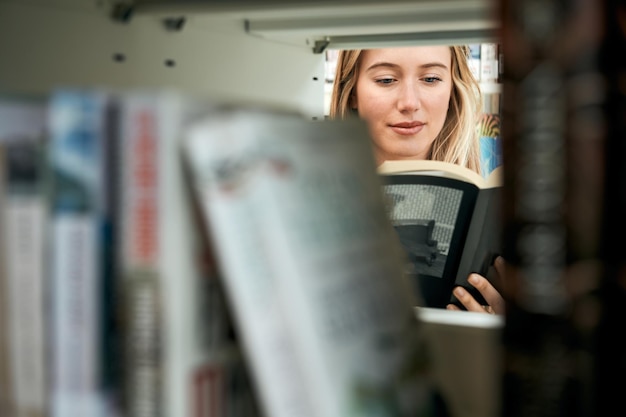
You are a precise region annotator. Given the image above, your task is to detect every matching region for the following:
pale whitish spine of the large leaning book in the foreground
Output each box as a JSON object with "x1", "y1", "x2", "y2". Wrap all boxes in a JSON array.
[{"x1": 186, "y1": 114, "x2": 313, "y2": 417}]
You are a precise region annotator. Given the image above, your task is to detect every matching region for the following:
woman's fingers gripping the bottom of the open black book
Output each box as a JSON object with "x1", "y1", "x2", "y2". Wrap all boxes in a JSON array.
[{"x1": 446, "y1": 256, "x2": 505, "y2": 314}]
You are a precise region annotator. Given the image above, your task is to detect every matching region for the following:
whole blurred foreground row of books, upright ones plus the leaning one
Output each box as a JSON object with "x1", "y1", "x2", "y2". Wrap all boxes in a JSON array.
[{"x1": 0, "y1": 89, "x2": 436, "y2": 417}]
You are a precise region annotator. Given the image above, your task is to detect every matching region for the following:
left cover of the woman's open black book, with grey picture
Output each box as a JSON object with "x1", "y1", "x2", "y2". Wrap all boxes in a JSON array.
[{"x1": 383, "y1": 173, "x2": 478, "y2": 308}]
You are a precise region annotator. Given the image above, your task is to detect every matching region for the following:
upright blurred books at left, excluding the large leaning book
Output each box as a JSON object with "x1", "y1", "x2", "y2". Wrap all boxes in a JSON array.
[{"x1": 0, "y1": 90, "x2": 259, "y2": 417}]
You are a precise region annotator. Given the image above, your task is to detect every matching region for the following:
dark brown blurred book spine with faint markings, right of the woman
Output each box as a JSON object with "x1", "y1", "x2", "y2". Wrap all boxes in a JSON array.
[{"x1": 499, "y1": 0, "x2": 605, "y2": 417}]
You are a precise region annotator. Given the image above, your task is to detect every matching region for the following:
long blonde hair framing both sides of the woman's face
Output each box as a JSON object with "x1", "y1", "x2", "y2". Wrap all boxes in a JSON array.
[{"x1": 330, "y1": 45, "x2": 482, "y2": 173}]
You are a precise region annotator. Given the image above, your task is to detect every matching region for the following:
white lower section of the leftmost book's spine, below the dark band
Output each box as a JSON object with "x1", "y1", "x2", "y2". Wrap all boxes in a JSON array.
[{"x1": 4, "y1": 195, "x2": 47, "y2": 415}]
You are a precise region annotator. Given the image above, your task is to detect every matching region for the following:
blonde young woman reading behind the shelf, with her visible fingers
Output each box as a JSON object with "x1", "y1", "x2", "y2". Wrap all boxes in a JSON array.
[{"x1": 330, "y1": 45, "x2": 504, "y2": 313}]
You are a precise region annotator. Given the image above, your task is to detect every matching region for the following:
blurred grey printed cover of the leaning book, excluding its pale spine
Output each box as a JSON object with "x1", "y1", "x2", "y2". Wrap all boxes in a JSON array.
[{"x1": 256, "y1": 115, "x2": 427, "y2": 417}]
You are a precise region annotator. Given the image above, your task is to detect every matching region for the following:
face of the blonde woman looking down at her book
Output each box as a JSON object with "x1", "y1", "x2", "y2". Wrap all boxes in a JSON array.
[{"x1": 351, "y1": 46, "x2": 452, "y2": 164}]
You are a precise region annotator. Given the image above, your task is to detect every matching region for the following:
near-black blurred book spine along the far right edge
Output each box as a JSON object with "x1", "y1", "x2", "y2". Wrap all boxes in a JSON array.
[{"x1": 594, "y1": 0, "x2": 626, "y2": 415}]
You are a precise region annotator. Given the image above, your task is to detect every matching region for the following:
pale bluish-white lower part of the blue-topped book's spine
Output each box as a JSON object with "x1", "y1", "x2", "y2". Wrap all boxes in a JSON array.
[{"x1": 51, "y1": 214, "x2": 104, "y2": 417}]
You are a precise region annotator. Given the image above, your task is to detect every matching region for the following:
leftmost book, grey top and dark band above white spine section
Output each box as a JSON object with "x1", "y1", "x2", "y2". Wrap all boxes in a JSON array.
[{"x1": 0, "y1": 96, "x2": 49, "y2": 416}]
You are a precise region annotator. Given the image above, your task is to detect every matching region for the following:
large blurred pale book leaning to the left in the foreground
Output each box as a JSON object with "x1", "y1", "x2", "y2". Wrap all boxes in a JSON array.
[{"x1": 182, "y1": 107, "x2": 434, "y2": 417}]
